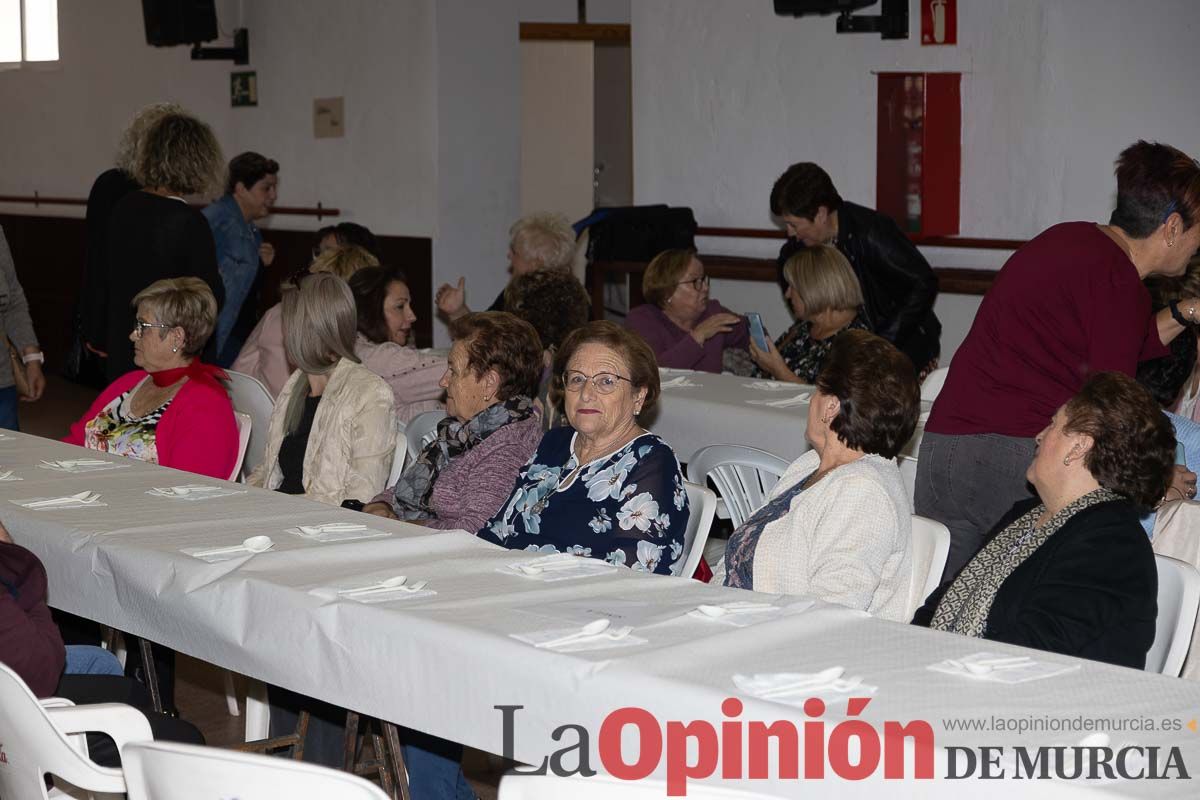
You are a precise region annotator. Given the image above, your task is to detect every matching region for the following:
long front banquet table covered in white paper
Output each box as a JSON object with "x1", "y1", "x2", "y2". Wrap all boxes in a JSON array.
[{"x1": 9, "y1": 433, "x2": 1200, "y2": 798}]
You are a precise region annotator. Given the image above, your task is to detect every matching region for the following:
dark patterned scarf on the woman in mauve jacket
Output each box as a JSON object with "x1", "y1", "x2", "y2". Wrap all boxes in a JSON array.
[{"x1": 392, "y1": 395, "x2": 535, "y2": 519}]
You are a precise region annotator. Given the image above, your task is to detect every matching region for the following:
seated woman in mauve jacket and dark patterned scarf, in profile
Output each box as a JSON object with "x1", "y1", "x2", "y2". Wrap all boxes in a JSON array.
[{"x1": 362, "y1": 311, "x2": 541, "y2": 531}]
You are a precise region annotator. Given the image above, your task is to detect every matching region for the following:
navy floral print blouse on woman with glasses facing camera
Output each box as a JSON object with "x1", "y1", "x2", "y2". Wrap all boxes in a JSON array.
[{"x1": 479, "y1": 426, "x2": 689, "y2": 575}]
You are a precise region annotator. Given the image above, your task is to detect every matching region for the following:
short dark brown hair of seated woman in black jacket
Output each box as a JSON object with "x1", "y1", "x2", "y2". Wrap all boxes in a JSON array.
[{"x1": 1063, "y1": 372, "x2": 1175, "y2": 509}]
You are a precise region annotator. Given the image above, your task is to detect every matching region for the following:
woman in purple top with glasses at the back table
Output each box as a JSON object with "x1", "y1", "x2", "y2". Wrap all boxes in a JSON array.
[{"x1": 625, "y1": 249, "x2": 750, "y2": 372}]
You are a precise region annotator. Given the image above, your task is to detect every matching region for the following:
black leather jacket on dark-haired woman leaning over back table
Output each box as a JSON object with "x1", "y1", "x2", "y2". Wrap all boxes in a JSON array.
[{"x1": 779, "y1": 203, "x2": 942, "y2": 369}]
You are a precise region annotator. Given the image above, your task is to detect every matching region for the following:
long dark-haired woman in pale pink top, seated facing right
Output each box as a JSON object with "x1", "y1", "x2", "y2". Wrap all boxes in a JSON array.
[{"x1": 349, "y1": 266, "x2": 446, "y2": 423}]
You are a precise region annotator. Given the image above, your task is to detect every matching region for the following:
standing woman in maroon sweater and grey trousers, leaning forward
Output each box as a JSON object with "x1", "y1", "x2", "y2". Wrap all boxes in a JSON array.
[{"x1": 916, "y1": 142, "x2": 1200, "y2": 578}]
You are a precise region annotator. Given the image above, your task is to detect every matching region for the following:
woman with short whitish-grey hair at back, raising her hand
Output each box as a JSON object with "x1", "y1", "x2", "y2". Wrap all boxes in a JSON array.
[{"x1": 434, "y1": 212, "x2": 575, "y2": 321}]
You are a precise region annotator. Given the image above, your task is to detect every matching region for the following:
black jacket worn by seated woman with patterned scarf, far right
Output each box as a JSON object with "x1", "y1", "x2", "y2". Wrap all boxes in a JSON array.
[{"x1": 912, "y1": 499, "x2": 1158, "y2": 669}]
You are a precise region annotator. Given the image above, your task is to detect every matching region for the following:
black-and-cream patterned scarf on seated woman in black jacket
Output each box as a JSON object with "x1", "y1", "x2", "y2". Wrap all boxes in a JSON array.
[{"x1": 929, "y1": 488, "x2": 1121, "y2": 638}]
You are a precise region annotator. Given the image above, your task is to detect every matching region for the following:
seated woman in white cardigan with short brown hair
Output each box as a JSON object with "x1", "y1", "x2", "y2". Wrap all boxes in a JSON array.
[{"x1": 716, "y1": 331, "x2": 920, "y2": 620}]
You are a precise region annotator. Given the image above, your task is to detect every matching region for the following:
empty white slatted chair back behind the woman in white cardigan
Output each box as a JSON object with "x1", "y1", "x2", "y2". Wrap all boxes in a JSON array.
[{"x1": 688, "y1": 445, "x2": 788, "y2": 528}]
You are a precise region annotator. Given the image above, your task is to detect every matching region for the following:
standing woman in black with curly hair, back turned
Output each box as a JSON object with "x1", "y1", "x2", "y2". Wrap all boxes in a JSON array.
[{"x1": 98, "y1": 113, "x2": 224, "y2": 380}]
